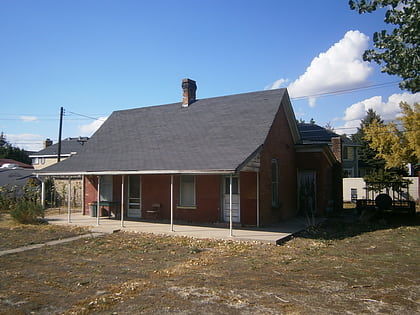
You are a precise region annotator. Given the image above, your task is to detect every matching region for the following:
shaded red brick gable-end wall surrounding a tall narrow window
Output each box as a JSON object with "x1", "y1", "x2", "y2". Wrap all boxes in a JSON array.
[{"x1": 260, "y1": 100, "x2": 297, "y2": 225}]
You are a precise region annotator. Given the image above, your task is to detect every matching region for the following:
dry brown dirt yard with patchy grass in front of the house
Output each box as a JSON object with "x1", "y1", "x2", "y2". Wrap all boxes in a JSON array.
[{"x1": 0, "y1": 211, "x2": 420, "y2": 314}]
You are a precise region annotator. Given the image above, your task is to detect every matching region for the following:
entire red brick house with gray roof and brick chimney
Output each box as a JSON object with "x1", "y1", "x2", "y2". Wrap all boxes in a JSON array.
[{"x1": 37, "y1": 79, "x2": 342, "y2": 226}]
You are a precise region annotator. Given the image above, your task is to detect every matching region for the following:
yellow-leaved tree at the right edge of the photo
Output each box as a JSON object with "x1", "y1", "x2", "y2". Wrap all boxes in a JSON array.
[{"x1": 364, "y1": 102, "x2": 420, "y2": 169}]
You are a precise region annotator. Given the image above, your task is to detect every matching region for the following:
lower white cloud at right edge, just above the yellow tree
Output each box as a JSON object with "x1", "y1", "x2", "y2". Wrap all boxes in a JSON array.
[{"x1": 337, "y1": 92, "x2": 420, "y2": 134}]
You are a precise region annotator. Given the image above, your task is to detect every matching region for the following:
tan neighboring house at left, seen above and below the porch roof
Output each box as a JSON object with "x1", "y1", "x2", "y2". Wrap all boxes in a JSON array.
[{"x1": 29, "y1": 137, "x2": 89, "y2": 207}]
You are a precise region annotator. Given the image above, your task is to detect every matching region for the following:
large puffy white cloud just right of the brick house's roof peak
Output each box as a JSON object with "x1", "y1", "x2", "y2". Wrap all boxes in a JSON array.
[{"x1": 271, "y1": 31, "x2": 373, "y2": 107}]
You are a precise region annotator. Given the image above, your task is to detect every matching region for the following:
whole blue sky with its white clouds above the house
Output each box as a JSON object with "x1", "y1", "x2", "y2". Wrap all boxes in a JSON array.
[{"x1": 0, "y1": 0, "x2": 420, "y2": 150}]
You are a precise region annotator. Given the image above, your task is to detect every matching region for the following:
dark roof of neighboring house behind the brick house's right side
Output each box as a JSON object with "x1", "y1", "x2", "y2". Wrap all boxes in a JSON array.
[{"x1": 297, "y1": 123, "x2": 355, "y2": 145}]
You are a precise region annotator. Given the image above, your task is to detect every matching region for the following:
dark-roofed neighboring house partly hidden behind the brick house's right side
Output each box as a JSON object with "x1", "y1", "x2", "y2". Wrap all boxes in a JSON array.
[{"x1": 298, "y1": 123, "x2": 360, "y2": 177}]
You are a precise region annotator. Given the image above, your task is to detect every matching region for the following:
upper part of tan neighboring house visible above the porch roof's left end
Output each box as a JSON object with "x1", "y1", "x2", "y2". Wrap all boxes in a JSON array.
[{"x1": 29, "y1": 137, "x2": 89, "y2": 170}]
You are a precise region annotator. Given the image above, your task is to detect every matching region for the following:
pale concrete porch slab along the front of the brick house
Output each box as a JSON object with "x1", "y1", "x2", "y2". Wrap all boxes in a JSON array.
[{"x1": 46, "y1": 213, "x2": 306, "y2": 244}]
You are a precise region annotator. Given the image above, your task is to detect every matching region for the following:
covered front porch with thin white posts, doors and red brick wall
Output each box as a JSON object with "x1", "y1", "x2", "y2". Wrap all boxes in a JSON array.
[{"x1": 39, "y1": 171, "x2": 260, "y2": 237}]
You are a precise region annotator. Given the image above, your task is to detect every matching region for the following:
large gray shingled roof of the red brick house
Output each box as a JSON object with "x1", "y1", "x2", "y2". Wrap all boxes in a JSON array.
[{"x1": 39, "y1": 89, "x2": 287, "y2": 173}]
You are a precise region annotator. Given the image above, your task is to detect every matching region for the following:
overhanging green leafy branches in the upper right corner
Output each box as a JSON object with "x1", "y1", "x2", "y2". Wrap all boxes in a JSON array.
[{"x1": 349, "y1": 0, "x2": 420, "y2": 93}]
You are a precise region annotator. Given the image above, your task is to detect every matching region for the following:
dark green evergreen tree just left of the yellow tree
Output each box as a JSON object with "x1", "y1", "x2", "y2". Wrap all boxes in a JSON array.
[{"x1": 352, "y1": 108, "x2": 385, "y2": 173}]
